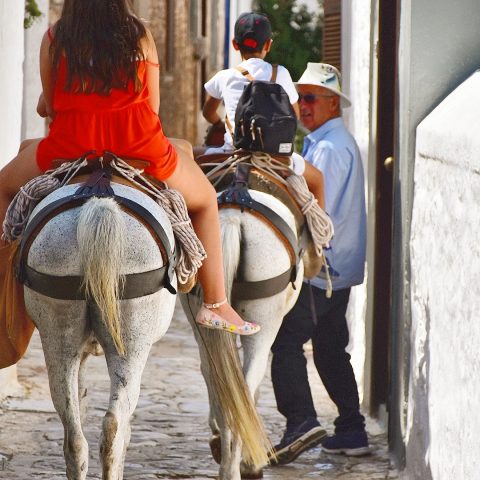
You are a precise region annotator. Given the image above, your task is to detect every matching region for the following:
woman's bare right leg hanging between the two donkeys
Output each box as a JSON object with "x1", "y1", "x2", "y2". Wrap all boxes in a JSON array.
[{"x1": 167, "y1": 139, "x2": 245, "y2": 326}]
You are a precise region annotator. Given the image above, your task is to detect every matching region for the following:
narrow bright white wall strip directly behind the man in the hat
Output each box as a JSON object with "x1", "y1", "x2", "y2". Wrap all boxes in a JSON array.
[{"x1": 342, "y1": 0, "x2": 371, "y2": 399}]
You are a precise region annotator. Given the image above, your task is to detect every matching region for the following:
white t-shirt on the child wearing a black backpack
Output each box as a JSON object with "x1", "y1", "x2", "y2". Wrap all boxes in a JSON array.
[{"x1": 205, "y1": 58, "x2": 298, "y2": 151}]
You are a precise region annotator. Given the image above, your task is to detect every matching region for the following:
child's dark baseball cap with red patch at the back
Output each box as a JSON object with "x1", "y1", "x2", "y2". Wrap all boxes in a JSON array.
[{"x1": 234, "y1": 12, "x2": 272, "y2": 52}]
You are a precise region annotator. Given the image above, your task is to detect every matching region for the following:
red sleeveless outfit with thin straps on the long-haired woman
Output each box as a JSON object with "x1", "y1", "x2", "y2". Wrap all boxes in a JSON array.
[{"x1": 36, "y1": 40, "x2": 178, "y2": 180}]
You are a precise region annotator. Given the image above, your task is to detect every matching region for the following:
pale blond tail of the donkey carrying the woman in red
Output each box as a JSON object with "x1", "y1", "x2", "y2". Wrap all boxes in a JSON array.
[{"x1": 77, "y1": 197, "x2": 126, "y2": 355}]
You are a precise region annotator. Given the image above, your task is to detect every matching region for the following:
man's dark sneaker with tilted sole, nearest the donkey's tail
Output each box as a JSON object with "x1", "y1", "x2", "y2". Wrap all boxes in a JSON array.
[{"x1": 270, "y1": 418, "x2": 327, "y2": 465}]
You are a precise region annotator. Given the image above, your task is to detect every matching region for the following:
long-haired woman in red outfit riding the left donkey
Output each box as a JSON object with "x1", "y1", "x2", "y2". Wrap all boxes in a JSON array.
[{"x1": 0, "y1": 0, "x2": 259, "y2": 335}]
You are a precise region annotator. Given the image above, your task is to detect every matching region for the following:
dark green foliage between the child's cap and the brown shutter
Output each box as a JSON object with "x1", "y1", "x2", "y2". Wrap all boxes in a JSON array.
[{"x1": 253, "y1": 0, "x2": 323, "y2": 81}]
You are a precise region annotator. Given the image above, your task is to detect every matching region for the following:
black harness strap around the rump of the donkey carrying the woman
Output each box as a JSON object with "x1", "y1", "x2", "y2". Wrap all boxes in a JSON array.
[{"x1": 17, "y1": 170, "x2": 177, "y2": 300}]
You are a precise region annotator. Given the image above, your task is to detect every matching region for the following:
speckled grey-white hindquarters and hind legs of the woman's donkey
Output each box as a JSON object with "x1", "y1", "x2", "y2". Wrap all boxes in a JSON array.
[{"x1": 25, "y1": 184, "x2": 175, "y2": 480}]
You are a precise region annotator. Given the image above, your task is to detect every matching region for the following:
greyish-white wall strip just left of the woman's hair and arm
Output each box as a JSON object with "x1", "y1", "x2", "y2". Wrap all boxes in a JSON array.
[{"x1": 22, "y1": 0, "x2": 49, "y2": 140}]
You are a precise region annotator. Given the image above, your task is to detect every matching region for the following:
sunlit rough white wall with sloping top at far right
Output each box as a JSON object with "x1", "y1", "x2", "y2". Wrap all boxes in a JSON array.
[{"x1": 406, "y1": 71, "x2": 480, "y2": 480}]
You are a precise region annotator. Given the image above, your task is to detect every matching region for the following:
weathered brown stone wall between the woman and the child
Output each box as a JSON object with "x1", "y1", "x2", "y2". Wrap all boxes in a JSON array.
[{"x1": 136, "y1": 0, "x2": 225, "y2": 145}]
